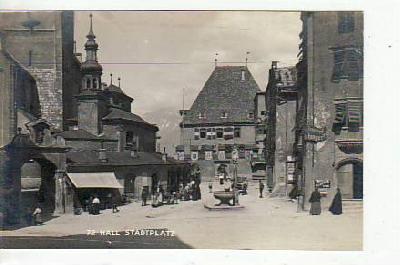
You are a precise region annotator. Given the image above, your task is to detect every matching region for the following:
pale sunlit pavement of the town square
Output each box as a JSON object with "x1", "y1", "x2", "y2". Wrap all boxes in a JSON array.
[{"x1": 1, "y1": 180, "x2": 363, "y2": 250}]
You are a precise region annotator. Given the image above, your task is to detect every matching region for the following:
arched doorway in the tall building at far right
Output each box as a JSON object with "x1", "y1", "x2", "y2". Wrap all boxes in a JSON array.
[{"x1": 336, "y1": 158, "x2": 363, "y2": 199}]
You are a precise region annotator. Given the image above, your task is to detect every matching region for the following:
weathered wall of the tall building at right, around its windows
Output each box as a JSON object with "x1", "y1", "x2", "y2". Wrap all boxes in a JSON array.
[{"x1": 303, "y1": 12, "x2": 363, "y2": 205}]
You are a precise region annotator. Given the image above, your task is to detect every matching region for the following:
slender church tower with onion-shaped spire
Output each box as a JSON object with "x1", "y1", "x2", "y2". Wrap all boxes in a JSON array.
[{"x1": 77, "y1": 14, "x2": 107, "y2": 135}]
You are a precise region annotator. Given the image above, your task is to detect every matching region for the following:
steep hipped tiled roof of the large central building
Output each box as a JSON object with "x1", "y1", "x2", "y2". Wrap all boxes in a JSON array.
[{"x1": 184, "y1": 66, "x2": 260, "y2": 126}]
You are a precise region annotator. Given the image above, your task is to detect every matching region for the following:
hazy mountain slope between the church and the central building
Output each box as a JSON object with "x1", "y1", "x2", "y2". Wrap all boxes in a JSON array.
[{"x1": 142, "y1": 108, "x2": 181, "y2": 155}]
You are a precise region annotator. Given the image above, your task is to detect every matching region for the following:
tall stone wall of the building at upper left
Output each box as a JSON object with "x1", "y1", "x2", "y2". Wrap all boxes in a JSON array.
[{"x1": 0, "y1": 11, "x2": 79, "y2": 129}]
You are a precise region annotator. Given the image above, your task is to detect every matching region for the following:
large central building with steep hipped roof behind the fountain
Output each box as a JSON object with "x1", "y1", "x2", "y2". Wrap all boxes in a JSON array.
[{"x1": 176, "y1": 66, "x2": 265, "y2": 177}]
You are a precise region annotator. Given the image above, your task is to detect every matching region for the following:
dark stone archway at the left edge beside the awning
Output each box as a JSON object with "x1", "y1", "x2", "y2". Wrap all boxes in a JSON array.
[{"x1": 0, "y1": 134, "x2": 72, "y2": 225}]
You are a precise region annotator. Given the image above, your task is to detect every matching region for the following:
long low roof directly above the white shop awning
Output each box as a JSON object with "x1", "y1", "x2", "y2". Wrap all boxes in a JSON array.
[{"x1": 67, "y1": 151, "x2": 175, "y2": 166}]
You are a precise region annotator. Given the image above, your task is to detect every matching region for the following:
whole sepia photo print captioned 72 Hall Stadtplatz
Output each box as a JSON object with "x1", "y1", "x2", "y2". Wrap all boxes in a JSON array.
[{"x1": 0, "y1": 10, "x2": 364, "y2": 251}]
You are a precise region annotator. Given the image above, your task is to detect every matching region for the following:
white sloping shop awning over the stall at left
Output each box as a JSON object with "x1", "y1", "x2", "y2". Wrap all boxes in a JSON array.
[{"x1": 68, "y1": 172, "x2": 123, "y2": 189}]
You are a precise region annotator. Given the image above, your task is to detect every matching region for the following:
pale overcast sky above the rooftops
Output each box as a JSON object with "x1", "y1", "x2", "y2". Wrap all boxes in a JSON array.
[{"x1": 75, "y1": 11, "x2": 301, "y2": 114}]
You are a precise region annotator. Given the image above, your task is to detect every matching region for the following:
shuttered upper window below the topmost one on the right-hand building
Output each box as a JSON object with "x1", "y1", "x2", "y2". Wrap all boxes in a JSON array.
[{"x1": 332, "y1": 47, "x2": 363, "y2": 82}]
